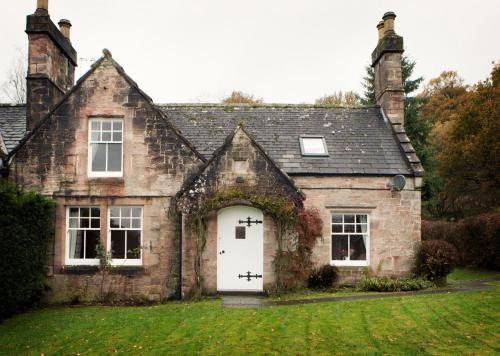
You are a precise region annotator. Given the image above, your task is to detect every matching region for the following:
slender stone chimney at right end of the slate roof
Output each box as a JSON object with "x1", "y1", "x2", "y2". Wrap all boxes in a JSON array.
[{"x1": 372, "y1": 12, "x2": 404, "y2": 131}]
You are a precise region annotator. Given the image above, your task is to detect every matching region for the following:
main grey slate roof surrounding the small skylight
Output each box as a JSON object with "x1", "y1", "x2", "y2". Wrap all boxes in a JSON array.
[{"x1": 159, "y1": 104, "x2": 414, "y2": 175}]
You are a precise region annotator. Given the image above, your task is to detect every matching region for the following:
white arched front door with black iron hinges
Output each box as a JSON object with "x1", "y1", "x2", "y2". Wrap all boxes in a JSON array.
[{"x1": 217, "y1": 205, "x2": 264, "y2": 292}]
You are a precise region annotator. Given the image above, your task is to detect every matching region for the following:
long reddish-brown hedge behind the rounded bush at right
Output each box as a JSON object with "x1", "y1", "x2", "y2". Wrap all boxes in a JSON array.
[{"x1": 422, "y1": 213, "x2": 500, "y2": 270}]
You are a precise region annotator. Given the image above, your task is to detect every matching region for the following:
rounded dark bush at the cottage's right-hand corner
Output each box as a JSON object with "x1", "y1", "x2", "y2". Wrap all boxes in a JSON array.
[{"x1": 415, "y1": 240, "x2": 458, "y2": 284}]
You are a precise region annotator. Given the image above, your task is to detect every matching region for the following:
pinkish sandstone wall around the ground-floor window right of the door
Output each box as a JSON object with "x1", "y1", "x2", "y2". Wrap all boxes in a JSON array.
[{"x1": 294, "y1": 177, "x2": 421, "y2": 283}]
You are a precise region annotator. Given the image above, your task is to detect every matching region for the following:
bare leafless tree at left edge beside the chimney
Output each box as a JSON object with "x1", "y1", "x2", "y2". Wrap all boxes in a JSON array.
[{"x1": 2, "y1": 52, "x2": 27, "y2": 104}]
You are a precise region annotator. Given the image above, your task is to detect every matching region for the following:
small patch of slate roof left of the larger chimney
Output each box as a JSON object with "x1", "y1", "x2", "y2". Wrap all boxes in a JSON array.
[{"x1": 0, "y1": 104, "x2": 26, "y2": 152}]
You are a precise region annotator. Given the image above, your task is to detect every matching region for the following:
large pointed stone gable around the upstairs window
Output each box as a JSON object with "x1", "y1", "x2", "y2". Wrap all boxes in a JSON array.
[{"x1": 9, "y1": 50, "x2": 205, "y2": 195}]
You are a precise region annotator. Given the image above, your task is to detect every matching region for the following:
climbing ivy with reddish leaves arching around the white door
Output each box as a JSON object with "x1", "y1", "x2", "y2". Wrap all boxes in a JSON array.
[{"x1": 180, "y1": 188, "x2": 322, "y2": 294}]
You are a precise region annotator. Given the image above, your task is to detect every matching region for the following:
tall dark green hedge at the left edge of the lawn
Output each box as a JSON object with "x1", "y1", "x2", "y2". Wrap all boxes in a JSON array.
[{"x1": 0, "y1": 180, "x2": 54, "y2": 320}]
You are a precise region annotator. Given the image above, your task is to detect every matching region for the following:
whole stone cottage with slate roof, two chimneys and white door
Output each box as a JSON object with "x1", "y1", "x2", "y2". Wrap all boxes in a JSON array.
[{"x1": 0, "y1": 0, "x2": 423, "y2": 301}]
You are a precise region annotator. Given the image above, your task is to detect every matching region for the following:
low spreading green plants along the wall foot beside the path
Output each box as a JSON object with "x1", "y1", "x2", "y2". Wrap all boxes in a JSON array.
[{"x1": 357, "y1": 276, "x2": 432, "y2": 292}]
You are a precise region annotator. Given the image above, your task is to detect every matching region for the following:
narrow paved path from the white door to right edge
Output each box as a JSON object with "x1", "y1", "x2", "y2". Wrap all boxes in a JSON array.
[{"x1": 222, "y1": 278, "x2": 500, "y2": 309}]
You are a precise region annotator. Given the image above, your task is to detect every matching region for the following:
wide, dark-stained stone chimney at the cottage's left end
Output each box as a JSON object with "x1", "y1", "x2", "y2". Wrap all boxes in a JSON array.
[{"x1": 26, "y1": 0, "x2": 77, "y2": 130}]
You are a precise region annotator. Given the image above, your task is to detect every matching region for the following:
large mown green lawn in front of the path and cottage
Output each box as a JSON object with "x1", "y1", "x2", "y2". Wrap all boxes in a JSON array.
[{"x1": 0, "y1": 288, "x2": 500, "y2": 355}]
